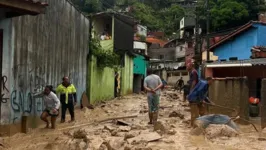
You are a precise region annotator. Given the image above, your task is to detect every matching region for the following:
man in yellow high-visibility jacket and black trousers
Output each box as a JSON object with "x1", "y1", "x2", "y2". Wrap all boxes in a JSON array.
[{"x1": 56, "y1": 77, "x2": 77, "y2": 123}]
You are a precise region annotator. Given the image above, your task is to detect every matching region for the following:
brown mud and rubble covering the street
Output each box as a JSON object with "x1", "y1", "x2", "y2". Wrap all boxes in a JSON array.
[{"x1": 0, "y1": 90, "x2": 266, "y2": 150}]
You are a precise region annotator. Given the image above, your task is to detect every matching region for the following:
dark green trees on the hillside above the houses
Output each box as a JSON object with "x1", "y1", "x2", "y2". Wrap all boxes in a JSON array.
[{"x1": 72, "y1": 0, "x2": 266, "y2": 36}]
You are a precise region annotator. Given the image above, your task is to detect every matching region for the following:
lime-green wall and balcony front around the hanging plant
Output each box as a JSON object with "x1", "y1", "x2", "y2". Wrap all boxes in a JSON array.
[{"x1": 89, "y1": 40, "x2": 114, "y2": 104}]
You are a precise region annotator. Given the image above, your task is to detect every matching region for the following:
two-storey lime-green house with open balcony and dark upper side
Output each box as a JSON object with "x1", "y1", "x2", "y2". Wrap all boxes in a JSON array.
[{"x1": 88, "y1": 12, "x2": 135, "y2": 103}]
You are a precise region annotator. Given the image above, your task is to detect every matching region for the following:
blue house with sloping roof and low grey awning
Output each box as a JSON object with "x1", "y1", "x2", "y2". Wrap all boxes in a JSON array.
[{"x1": 205, "y1": 21, "x2": 266, "y2": 109}]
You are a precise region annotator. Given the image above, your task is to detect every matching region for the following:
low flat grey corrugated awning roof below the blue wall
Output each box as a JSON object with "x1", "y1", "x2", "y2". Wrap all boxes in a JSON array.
[{"x1": 206, "y1": 58, "x2": 266, "y2": 67}]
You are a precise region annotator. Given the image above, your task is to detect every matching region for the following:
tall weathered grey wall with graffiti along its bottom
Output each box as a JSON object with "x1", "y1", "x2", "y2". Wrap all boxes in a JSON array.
[{"x1": 0, "y1": 0, "x2": 89, "y2": 134}]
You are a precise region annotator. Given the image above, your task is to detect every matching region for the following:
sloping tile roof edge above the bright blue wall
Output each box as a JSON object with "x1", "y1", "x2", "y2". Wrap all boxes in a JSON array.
[{"x1": 210, "y1": 21, "x2": 266, "y2": 50}]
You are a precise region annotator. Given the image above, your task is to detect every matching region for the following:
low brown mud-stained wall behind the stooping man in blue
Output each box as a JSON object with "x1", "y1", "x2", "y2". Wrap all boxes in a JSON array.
[{"x1": 209, "y1": 78, "x2": 249, "y2": 123}]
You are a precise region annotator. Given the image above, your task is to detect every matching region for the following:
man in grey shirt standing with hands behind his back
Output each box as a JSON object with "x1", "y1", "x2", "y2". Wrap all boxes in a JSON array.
[{"x1": 144, "y1": 69, "x2": 163, "y2": 124}]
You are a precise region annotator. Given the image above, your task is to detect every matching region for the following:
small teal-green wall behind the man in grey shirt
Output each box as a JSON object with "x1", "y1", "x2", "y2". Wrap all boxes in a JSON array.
[{"x1": 134, "y1": 55, "x2": 147, "y2": 76}]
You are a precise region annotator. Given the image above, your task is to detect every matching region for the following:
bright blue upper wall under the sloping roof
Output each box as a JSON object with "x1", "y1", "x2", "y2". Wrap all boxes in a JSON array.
[{"x1": 214, "y1": 28, "x2": 256, "y2": 60}]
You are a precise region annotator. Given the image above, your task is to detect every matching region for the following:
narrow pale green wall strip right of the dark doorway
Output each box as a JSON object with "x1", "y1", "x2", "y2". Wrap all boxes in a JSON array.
[{"x1": 121, "y1": 55, "x2": 134, "y2": 95}]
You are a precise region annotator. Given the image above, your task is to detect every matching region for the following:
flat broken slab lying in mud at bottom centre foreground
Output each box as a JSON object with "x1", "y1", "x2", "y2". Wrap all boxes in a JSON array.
[{"x1": 127, "y1": 132, "x2": 162, "y2": 144}]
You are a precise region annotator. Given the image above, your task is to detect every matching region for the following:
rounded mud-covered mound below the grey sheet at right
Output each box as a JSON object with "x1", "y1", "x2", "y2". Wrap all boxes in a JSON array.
[{"x1": 205, "y1": 124, "x2": 238, "y2": 140}]
